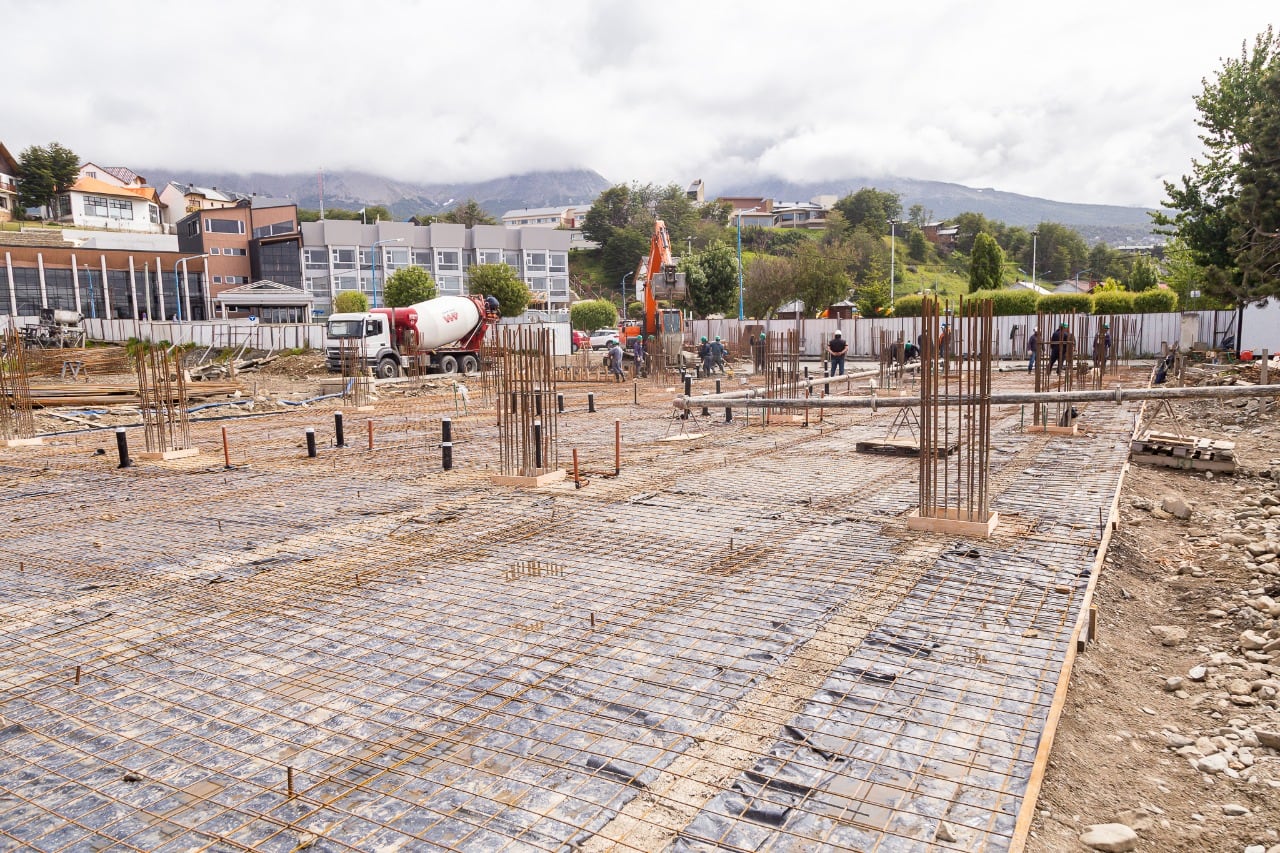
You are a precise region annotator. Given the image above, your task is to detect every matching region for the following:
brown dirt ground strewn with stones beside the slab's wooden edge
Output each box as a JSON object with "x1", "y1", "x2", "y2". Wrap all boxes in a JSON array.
[{"x1": 1027, "y1": 379, "x2": 1280, "y2": 853}]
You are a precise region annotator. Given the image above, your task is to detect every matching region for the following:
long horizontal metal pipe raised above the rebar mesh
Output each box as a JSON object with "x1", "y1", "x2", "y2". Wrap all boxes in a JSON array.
[{"x1": 675, "y1": 384, "x2": 1280, "y2": 410}]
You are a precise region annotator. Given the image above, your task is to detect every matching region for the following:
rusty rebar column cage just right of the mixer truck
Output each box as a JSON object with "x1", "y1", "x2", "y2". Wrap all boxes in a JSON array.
[{"x1": 497, "y1": 328, "x2": 559, "y2": 476}]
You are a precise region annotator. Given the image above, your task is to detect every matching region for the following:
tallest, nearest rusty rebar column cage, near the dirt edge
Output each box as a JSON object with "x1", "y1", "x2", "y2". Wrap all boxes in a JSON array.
[{"x1": 919, "y1": 300, "x2": 993, "y2": 523}]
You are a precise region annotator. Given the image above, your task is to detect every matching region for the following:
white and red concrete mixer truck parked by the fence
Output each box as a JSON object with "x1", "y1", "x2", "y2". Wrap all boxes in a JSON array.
[{"x1": 325, "y1": 296, "x2": 498, "y2": 379}]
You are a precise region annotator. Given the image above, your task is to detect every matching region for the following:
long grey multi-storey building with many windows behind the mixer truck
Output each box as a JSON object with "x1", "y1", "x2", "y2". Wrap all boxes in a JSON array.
[{"x1": 302, "y1": 219, "x2": 570, "y2": 311}]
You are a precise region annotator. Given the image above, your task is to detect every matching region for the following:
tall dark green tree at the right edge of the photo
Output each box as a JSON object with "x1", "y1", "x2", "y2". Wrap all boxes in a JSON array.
[{"x1": 1152, "y1": 27, "x2": 1280, "y2": 300}]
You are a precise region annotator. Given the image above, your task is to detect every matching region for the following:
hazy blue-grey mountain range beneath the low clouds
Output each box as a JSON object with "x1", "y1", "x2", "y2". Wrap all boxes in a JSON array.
[{"x1": 141, "y1": 169, "x2": 1156, "y2": 246}]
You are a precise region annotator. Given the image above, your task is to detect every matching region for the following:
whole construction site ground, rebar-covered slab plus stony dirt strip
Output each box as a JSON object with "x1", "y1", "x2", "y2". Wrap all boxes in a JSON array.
[{"x1": 0, "y1": 356, "x2": 1280, "y2": 852}]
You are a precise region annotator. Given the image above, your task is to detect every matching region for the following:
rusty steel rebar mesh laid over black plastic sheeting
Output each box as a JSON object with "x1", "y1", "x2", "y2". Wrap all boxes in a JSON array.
[{"x1": 0, "y1": 361, "x2": 1132, "y2": 853}]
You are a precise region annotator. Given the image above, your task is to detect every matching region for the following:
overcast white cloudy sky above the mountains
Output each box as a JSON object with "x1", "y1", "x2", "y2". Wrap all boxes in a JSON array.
[{"x1": 0, "y1": 0, "x2": 1280, "y2": 205}]
